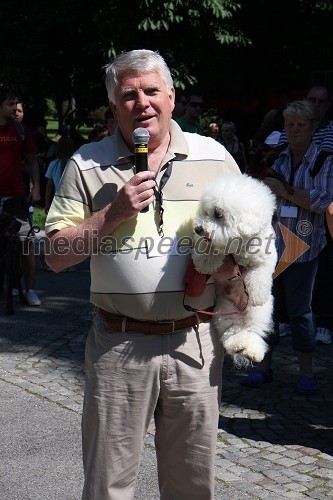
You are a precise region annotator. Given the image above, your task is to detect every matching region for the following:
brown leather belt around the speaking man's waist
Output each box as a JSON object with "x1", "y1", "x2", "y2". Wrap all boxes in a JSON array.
[{"x1": 96, "y1": 307, "x2": 211, "y2": 335}]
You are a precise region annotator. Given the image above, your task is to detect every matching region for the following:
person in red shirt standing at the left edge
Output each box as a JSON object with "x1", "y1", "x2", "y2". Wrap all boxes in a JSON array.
[{"x1": 0, "y1": 84, "x2": 41, "y2": 306}]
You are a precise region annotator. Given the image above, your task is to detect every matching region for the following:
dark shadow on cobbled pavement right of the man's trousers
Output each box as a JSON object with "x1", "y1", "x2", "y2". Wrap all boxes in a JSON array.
[{"x1": 219, "y1": 337, "x2": 333, "y2": 455}]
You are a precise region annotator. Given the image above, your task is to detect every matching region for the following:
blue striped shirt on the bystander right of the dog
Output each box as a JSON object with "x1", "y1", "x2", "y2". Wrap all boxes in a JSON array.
[{"x1": 273, "y1": 142, "x2": 333, "y2": 263}]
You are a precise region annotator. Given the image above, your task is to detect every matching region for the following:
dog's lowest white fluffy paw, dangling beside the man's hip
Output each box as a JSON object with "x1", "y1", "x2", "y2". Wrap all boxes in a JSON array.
[{"x1": 222, "y1": 330, "x2": 268, "y2": 363}]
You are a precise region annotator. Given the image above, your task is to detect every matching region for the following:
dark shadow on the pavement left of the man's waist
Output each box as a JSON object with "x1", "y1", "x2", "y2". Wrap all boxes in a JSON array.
[{"x1": 0, "y1": 261, "x2": 93, "y2": 363}]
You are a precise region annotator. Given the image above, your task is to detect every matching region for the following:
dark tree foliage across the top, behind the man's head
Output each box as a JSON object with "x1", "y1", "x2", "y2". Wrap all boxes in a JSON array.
[{"x1": 0, "y1": 0, "x2": 333, "y2": 129}]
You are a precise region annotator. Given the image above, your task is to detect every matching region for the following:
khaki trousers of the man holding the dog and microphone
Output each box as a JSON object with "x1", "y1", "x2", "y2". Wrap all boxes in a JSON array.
[{"x1": 82, "y1": 315, "x2": 223, "y2": 500}]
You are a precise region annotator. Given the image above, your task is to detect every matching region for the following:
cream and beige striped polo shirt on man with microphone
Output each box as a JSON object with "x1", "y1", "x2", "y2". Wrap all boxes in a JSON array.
[{"x1": 46, "y1": 121, "x2": 240, "y2": 321}]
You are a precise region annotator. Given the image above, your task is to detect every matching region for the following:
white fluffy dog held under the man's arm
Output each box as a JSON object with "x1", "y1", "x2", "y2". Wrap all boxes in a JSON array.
[{"x1": 192, "y1": 175, "x2": 277, "y2": 366}]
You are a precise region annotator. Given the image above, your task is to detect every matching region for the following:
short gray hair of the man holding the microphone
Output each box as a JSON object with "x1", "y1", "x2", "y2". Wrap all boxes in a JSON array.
[{"x1": 104, "y1": 49, "x2": 173, "y2": 102}]
